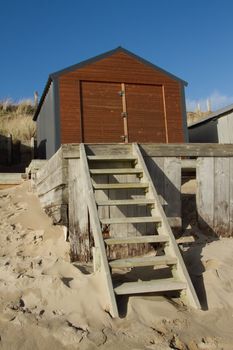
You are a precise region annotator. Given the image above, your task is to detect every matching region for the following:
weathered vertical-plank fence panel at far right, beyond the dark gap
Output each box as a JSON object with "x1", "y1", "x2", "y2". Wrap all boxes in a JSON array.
[{"x1": 197, "y1": 157, "x2": 233, "y2": 236}]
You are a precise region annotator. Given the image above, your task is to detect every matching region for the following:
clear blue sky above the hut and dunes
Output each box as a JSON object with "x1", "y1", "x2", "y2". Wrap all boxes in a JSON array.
[{"x1": 0, "y1": 0, "x2": 233, "y2": 110}]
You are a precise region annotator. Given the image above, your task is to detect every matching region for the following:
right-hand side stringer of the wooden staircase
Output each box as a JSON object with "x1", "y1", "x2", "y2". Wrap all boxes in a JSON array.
[{"x1": 132, "y1": 143, "x2": 201, "y2": 309}]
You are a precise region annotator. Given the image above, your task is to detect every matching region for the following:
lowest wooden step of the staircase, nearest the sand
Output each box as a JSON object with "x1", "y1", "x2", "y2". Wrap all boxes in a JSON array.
[{"x1": 114, "y1": 278, "x2": 186, "y2": 295}]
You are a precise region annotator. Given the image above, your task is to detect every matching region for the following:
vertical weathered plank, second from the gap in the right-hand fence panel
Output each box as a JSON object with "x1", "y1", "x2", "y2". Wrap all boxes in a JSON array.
[{"x1": 213, "y1": 157, "x2": 230, "y2": 236}]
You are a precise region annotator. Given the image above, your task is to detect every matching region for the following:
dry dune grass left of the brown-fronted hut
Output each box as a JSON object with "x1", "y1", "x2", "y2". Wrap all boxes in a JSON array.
[{"x1": 0, "y1": 99, "x2": 36, "y2": 142}]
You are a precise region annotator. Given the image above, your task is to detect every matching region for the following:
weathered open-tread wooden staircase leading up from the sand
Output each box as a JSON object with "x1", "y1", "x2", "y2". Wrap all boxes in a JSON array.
[{"x1": 80, "y1": 144, "x2": 200, "y2": 317}]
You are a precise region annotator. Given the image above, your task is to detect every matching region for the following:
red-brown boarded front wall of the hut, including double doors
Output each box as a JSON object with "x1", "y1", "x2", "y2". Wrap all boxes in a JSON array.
[{"x1": 59, "y1": 52, "x2": 184, "y2": 143}]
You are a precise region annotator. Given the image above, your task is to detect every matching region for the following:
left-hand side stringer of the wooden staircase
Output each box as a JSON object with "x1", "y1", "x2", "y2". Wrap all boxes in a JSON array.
[{"x1": 80, "y1": 144, "x2": 119, "y2": 317}]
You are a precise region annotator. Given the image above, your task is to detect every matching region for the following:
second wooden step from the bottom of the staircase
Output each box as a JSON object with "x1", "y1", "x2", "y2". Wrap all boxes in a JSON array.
[{"x1": 109, "y1": 255, "x2": 177, "y2": 269}]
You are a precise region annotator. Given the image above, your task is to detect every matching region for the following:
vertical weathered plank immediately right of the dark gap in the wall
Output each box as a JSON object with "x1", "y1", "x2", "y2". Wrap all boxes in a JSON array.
[{"x1": 196, "y1": 157, "x2": 214, "y2": 230}]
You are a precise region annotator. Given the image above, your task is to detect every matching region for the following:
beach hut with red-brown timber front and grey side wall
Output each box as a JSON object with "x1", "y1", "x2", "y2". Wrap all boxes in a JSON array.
[{"x1": 34, "y1": 47, "x2": 187, "y2": 158}]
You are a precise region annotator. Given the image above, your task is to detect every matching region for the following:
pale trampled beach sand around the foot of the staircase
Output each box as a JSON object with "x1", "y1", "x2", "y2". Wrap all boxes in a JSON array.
[{"x1": 0, "y1": 182, "x2": 233, "y2": 350}]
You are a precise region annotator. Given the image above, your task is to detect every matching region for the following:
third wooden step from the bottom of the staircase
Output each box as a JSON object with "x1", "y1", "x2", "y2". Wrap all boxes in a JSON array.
[{"x1": 104, "y1": 235, "x2": 169, "y2": 245}]
